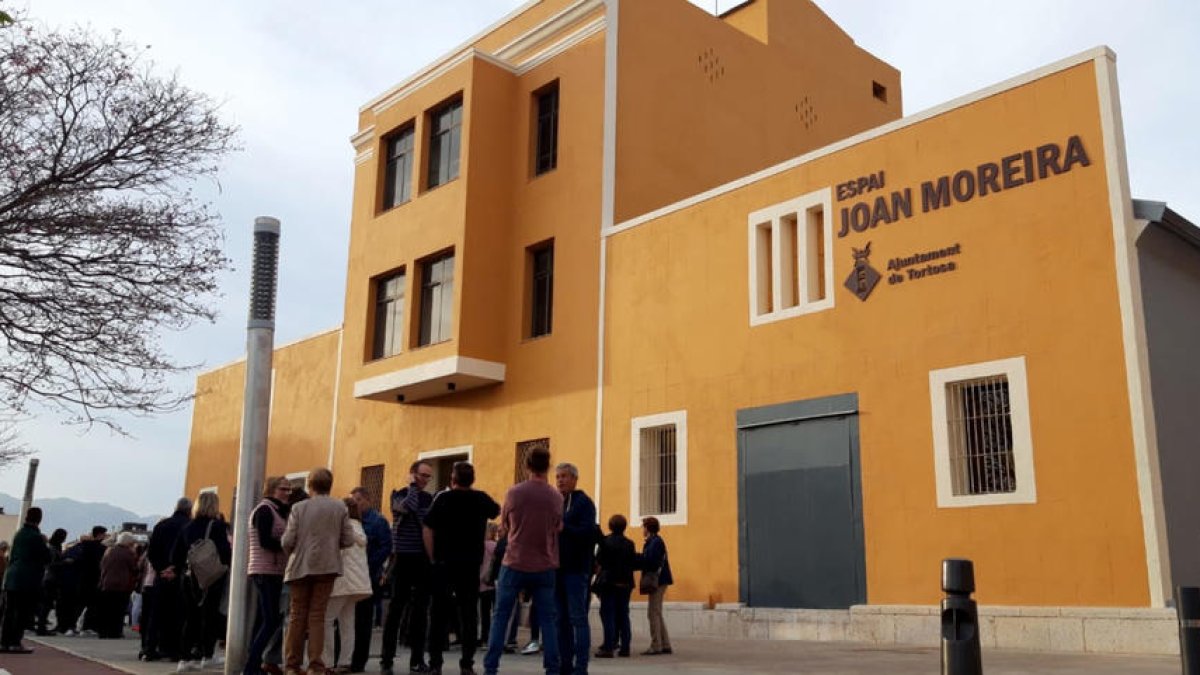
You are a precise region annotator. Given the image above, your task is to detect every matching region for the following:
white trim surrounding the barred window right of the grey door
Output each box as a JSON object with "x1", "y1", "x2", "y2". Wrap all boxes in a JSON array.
[{"x1": 929, "y1": 357, "x2": 1038, "y2": 508}]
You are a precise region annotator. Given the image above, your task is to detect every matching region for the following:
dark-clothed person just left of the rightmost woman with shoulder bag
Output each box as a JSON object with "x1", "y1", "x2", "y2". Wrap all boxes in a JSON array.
[{"x1": 594, "y1": 514, "x2": 637, "y2": 658}]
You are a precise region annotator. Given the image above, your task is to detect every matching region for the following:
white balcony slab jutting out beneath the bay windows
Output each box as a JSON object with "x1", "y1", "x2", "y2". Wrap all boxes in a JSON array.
[{"x1": 354, "y1": 357, "x2": 504, "y2": 404}]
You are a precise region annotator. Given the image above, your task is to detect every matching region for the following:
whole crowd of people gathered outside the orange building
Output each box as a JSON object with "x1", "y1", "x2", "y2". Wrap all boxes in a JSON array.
[{"x1": 0, "y1": 449, "x2": 673, "y2": 675}]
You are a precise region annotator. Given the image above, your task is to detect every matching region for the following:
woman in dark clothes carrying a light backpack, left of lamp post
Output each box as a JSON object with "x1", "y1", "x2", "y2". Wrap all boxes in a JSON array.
[{"x1": 172, "y1": 485, "x2": 233, "y2": 673}]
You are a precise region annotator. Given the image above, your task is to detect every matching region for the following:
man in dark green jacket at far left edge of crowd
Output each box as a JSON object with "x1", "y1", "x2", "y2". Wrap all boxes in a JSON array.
[{"x1": 0, "y1": 507, "x2": 50, "y2": 653}]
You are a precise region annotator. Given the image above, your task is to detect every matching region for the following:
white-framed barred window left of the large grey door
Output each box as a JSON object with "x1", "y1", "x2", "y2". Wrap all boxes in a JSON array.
[{"x1": 629, "y1": 411, "x2": 688, "y2": 525}]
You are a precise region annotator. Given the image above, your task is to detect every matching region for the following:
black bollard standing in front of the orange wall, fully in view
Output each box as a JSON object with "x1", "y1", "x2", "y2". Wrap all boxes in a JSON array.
[{"x1": 942, "y1": 557, "x2": 983, "y2": 675}]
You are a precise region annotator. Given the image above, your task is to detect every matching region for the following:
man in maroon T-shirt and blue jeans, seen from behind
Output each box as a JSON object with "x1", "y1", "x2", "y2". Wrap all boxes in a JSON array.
[{"x1": 484, "y1": 448, "x2": 563, "y2": 675}]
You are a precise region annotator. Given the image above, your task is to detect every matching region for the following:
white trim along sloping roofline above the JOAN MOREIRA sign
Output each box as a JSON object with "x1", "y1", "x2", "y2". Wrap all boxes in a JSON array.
[{"x1": 600, "y1": 46, "x2": 1116, "y2": 237}]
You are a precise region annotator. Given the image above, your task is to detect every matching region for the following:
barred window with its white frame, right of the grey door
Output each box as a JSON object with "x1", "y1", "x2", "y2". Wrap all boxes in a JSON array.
[{"x1": 929, "y1": 357, "x2": 1037, "y2": 507}]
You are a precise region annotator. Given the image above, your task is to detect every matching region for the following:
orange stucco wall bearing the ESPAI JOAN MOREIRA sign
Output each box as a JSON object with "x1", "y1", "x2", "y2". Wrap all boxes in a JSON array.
[{"x1": 604, "y1": 62, "x2": 1148, "y2": 605}]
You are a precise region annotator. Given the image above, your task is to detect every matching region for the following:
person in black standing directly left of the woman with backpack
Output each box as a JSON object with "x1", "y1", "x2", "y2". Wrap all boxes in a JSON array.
[{"x1": 143, "y1": 497, "x2": 192, "y2": 661}]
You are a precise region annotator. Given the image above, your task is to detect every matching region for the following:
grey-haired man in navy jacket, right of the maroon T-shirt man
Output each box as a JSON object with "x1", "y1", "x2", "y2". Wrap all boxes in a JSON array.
[{"x1": 554, "y1": 462, "x2": 600, "y2": 675}]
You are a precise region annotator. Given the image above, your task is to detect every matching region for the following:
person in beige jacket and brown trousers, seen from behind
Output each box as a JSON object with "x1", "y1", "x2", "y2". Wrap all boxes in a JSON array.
[{"x1": 282, "y1": 467, "x2": 354, "y2": 675}]
